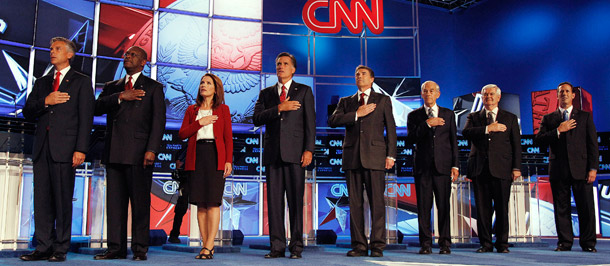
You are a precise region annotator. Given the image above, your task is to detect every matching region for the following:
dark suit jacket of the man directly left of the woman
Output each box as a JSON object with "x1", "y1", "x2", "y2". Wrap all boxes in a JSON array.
[{"x1": 95, "y1": 74, "x2": 165, "y2": 165}]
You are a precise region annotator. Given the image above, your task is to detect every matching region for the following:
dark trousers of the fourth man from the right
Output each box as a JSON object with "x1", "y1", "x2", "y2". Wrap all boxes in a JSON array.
[{"x1": 345, "y1": 168, "x2": 386, "y2": 251}]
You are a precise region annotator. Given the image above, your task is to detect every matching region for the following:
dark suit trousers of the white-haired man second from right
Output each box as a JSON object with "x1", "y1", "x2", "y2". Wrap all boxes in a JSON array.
[{"x1": 472, "y1": 161, "x2": 512, "y2": 250}]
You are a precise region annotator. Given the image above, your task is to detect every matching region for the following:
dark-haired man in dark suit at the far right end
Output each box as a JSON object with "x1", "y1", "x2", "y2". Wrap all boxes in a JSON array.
[{"x1": 536, "y1": 82, "x2": 599, "y2": 252}]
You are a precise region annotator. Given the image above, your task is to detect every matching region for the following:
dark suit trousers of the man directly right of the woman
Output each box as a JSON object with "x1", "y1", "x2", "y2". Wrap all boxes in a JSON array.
[{"x1": 266, "y1": 160, "x2": 305, "y2": 253}]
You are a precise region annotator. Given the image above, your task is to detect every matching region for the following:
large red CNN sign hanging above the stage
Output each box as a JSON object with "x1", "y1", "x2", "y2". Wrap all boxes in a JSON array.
[{"x1": 302, "y1": 0, "x2": 383, "y2": 34}]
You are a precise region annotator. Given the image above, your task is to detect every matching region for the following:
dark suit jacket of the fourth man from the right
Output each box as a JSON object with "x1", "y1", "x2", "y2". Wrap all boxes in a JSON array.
[{"x1": 328, "y1": 90, "x2": 396, "y2": 170}]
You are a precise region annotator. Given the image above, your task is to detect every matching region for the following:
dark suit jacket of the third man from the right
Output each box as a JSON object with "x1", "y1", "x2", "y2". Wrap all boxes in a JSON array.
[{"x1": 407, "y1": 106, "x2": 459, "y2": 175}]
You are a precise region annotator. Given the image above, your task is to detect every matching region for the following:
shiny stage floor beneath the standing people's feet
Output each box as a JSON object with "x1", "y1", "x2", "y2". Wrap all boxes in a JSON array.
[{"x1": 0, "y1": 237, "x2": 610, "y2": 266}]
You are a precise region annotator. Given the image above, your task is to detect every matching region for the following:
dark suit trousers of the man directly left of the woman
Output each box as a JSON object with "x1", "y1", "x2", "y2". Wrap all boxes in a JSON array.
[{"x1": 106, "y1": 163, "x2": 152, "y2": 254}]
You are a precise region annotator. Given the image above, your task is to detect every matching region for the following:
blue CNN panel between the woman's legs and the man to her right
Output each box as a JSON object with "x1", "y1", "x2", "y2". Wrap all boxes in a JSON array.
[{"x1": 222, "y1": 181, "x2": 262, "y2": 235}]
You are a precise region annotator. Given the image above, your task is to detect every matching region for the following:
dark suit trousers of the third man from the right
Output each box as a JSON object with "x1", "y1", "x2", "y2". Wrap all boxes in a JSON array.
[{"x1": 415, "y1": 163, "x2": 451, "y2": 247}]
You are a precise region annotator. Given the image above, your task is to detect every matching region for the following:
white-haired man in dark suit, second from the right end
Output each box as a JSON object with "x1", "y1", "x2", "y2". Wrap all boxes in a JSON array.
[{"x1": 462, "y1": 84, "x2": 521, "y2": 253}]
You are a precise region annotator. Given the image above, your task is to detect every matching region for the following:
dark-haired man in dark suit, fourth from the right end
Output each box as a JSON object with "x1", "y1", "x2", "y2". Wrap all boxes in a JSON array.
[{"x1": 328, "y1": 65, "x2": 396, "y2": 257}]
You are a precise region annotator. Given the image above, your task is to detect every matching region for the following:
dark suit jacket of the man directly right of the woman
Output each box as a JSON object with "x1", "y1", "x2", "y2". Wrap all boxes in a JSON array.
[{"x1": 253, "y1": 80, "x2": 316, "y2": 165}]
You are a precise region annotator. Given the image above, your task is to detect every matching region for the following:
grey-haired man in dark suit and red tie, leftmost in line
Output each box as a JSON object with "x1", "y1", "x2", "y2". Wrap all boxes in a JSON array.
[{"x1": 21, "y1": 37, "x2": 95, "y2": 261}]
